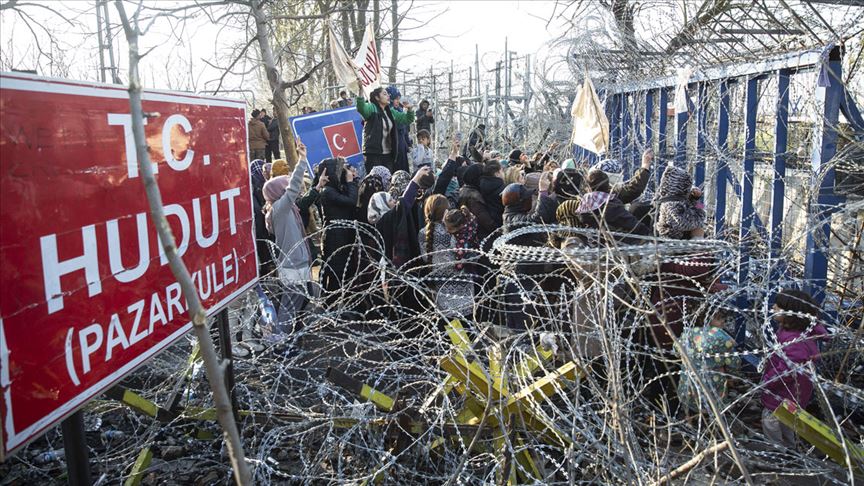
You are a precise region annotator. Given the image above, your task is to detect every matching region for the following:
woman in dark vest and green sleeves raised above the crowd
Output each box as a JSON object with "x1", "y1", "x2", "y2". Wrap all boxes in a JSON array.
[{"x1": 356, "y1": 88, "x2": 414, "y2": 174}]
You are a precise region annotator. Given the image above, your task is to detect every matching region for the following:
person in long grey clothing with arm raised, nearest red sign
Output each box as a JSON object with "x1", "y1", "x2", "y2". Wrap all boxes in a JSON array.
[{"x1": 262, "y1": 143, "x2": 326, "y2": 329}]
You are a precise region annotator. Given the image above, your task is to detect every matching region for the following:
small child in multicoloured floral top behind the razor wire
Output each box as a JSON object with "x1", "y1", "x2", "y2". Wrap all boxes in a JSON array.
[{"x1": 678, "y1": 309, "x2": 735, "y2": 415}]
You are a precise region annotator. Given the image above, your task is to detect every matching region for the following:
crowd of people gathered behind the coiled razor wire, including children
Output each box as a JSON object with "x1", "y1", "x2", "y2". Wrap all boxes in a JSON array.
[{"x1": 249, "y1": 87, "x2": 826, "y2": 450}]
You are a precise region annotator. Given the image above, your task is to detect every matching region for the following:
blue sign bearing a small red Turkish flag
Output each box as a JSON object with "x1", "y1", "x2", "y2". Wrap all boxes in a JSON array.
[{"x1": 289, "y1": 106, "x2": 363, "y2": 177}]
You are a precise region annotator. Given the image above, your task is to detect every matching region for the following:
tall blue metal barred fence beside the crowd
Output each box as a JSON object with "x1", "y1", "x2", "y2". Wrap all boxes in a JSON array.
[{"x1": 607, "y1": 46, "x2": 864, "y2": 342}]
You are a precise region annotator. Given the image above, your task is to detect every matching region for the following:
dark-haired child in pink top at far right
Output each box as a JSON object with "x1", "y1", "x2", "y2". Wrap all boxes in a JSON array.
[{"x1": 762, "y1": 289, "x2": 827, "y2": 447}]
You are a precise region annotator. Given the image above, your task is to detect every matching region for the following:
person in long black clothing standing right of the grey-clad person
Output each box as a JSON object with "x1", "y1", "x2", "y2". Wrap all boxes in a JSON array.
[{"x1": 315, "y1": 157, "x2": 357, "y2": 292}]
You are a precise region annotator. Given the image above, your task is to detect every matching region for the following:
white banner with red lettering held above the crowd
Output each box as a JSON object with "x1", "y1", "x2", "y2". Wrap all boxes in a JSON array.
[{"x1": 330, "y1": 24, "x2": 381, "y2": 96}]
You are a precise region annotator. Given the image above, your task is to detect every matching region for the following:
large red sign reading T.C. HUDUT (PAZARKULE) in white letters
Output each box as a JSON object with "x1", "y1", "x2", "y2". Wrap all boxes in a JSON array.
[{"x1": 0, "y1": 73, "x2": 258, "y2": 455}]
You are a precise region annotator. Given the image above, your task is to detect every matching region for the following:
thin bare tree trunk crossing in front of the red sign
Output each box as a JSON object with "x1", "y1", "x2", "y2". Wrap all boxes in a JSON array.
[{"x1": 114, "y1": 0, "x2": 252, "y2": 485}]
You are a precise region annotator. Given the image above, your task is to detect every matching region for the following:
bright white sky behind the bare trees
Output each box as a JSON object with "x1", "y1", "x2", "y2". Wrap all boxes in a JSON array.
[{"x1": 0, "y1": 0, "x2": 568, "y2": 97}]
